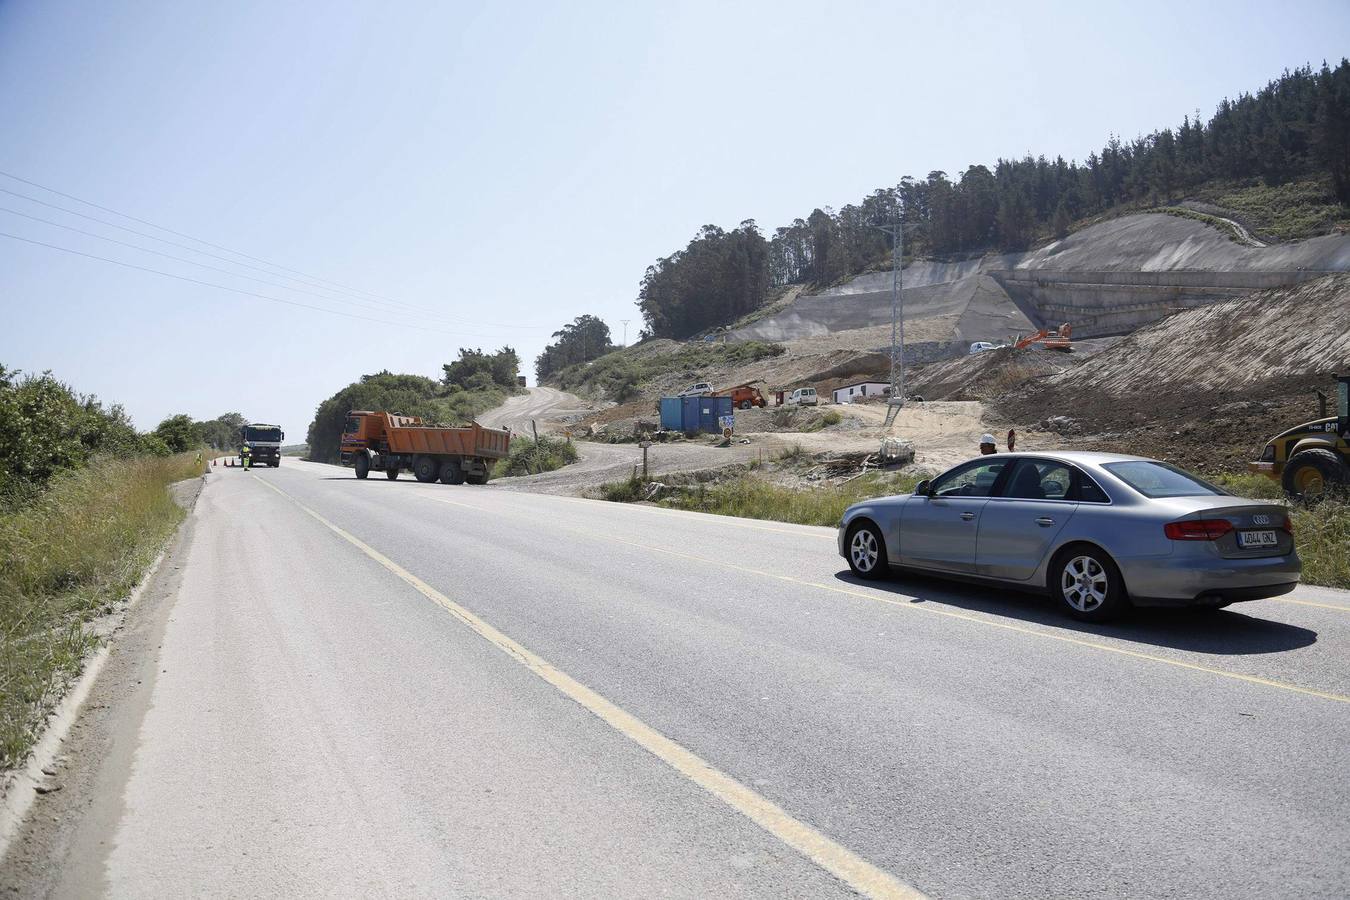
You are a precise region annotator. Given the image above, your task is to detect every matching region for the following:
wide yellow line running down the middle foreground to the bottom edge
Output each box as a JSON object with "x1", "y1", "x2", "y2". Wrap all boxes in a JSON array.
[{"x1": 259, "y1": 479, "x2": 923, "y2": 900}]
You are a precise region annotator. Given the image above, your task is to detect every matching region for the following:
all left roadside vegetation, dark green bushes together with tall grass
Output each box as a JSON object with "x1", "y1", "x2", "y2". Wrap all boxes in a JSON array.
[{"x1": 0, "y1": 367, "x2": 207, "y2": 768}]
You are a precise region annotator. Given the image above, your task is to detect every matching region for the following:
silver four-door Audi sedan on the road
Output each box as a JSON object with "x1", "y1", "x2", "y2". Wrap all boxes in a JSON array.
[{"x1": 838, "y1": 452, "x2": 1303, "y2": 621}]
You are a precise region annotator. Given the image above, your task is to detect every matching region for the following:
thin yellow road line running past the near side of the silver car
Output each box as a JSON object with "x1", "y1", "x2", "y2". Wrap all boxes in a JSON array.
[{"x1": 413, "y1": 488, "x2": 1350, "y2": 703}]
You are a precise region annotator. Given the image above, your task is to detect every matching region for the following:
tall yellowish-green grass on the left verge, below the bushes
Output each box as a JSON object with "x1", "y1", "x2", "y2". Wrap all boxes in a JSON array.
[{"x1": 0, "y1": 452, "x2": 203, "y2": 769}]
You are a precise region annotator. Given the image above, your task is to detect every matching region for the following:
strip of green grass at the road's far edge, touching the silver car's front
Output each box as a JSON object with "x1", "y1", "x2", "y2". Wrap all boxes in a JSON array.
[{"x1": 601, "y1": 472, "x2": 921, "y2": 528}]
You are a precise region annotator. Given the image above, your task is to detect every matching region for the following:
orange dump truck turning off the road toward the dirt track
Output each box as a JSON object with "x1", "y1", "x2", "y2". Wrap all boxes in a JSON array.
[{"x1": 342, "y1": 410, "x2": 510, "y2": 484}]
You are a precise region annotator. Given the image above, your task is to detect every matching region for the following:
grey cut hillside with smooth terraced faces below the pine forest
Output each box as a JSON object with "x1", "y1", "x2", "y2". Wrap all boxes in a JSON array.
[{"x1": 730, "y1": 213, "x2": 1350, "y2": 350}]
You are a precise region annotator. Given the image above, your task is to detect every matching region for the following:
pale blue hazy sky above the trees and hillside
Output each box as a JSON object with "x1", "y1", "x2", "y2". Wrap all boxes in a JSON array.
[{"x1": 0, "y1": 0, "x2": 1350, "y2": 443}]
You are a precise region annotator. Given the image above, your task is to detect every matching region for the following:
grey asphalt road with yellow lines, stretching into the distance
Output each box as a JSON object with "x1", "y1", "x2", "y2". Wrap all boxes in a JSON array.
[{"x1": 13, "y1": 459, "x2": 1350, "y2": 897}]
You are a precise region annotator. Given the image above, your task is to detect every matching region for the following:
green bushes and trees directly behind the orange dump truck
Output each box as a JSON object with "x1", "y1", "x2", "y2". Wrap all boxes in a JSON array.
[{"x1": 305, "y1": 347, "x2": 525, "y2": 463}]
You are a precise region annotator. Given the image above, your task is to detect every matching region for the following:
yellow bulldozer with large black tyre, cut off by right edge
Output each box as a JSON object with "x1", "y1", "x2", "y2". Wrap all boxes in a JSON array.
[{"x1": 1247, "y1": 375, "x2": 1350, "y2": 498}]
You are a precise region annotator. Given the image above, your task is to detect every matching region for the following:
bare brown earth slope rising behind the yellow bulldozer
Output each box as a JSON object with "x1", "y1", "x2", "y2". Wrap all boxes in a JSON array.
[{"x1": 992, "y1": 275, "x2": 1350, "y2": 471}]
